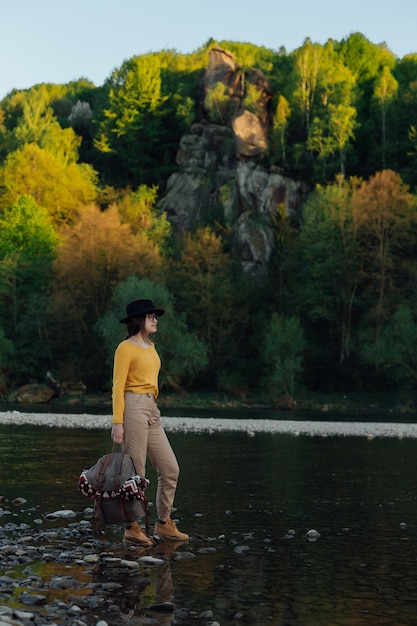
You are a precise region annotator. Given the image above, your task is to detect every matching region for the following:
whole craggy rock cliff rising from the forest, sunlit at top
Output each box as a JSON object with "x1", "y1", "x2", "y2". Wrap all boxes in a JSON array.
[{"x1": 159, "y1": 48, "x2": 306, "y2": 276}]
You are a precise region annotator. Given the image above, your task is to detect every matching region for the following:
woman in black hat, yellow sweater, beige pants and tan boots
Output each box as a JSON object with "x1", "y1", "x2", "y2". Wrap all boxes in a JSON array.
[{"x1": 112, "y1": 300, "x2": 189, "y2": 546}]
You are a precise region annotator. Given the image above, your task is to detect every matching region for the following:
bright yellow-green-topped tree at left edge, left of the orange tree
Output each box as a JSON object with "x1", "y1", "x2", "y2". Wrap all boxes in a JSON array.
[{"x1": 0, "y1": 196, "x2": 59, "y2": 380}]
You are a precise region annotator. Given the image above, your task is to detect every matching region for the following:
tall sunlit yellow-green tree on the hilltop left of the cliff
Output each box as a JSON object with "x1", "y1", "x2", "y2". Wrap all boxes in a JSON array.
[{"x1": 95, "y1": 54, "x2": 183, "y2": 187}]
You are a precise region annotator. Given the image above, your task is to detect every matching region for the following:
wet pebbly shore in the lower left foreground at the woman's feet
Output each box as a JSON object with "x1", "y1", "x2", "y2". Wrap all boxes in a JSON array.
[{"x1": 0, "y1": 510, "x2": 221, "y2": 626}]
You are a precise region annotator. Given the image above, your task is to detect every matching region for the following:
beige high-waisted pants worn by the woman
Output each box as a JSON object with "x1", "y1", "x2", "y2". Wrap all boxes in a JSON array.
[{"x1": 124, "y1": 391, "x2": 179, "y2": 520}]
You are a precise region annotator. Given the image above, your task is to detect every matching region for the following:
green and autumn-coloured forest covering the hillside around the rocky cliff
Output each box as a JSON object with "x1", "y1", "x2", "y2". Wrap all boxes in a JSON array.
[{"x1": 0, "y1": 33, "x2": 417, "y2": 406}]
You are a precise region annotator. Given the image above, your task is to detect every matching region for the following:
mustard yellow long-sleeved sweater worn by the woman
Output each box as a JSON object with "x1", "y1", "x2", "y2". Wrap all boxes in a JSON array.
[{"x1": 112, "y1": 339, "x2": 161, "y2": 424}]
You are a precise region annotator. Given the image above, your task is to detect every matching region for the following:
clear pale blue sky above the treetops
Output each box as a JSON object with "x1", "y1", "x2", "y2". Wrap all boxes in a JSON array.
[{"x1": 0, "y1": 0, "x2": 417, "y2": 100}]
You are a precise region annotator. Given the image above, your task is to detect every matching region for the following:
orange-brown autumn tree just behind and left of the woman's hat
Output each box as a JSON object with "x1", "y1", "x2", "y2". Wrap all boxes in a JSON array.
[{"x1": 44, "y1": 205, "x2": 163, "y2": 382}]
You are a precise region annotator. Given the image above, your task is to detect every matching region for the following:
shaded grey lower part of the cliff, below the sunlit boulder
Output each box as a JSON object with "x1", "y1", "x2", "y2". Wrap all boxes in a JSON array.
[{"x1": 158, "y1": 128, "x2": 307, "y2": 276}]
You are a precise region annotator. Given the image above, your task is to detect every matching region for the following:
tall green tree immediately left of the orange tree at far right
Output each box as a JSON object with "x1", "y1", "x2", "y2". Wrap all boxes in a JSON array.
[{"x1": 294, "y1": 178, "x2": 361, "y2": 363}]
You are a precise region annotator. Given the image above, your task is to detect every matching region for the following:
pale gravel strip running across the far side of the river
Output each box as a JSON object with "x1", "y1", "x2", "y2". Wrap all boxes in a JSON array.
[{"x1": 0, "y1": 411, "x2": 417, "y2": 439}]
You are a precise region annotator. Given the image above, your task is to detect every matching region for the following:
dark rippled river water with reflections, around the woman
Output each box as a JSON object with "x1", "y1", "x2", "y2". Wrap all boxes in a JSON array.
[{"x1": 0, "y1": 427, "x2": 417, "y2": 626}]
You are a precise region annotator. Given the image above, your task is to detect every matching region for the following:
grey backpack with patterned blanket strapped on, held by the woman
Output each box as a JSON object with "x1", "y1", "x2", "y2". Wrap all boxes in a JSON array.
[{"x1": 78, "y1": 451, "x2": 149, "y2": 535}]
